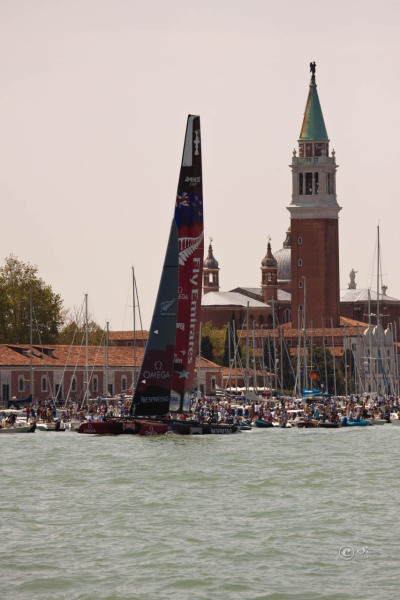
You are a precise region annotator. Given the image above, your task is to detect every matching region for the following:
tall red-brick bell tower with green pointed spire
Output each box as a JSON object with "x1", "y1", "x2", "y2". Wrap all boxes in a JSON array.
[{"x1": 288, "y1": 63, "x2": 341, "y2": 328}]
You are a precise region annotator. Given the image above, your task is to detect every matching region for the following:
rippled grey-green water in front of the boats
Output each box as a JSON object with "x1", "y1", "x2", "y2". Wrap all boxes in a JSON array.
[{"x1": 0, "y1": 425, "x2": 400, "y2": 600}]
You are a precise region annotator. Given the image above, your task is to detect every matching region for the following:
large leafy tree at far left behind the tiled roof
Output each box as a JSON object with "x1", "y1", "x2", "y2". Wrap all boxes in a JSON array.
[{"x1": 0, "y1": 254, "x2": 62, "y2": 344}]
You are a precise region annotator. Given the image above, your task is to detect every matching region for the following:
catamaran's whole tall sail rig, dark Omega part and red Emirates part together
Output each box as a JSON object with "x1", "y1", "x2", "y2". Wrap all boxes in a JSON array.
[{"x1": 131, "y1": 115, "x2": 204, "y2": 416}]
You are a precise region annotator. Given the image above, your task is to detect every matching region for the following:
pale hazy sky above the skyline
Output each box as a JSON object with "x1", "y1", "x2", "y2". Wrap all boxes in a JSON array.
[{"x1": 0, "y1": 0, "x2": 400, "y2": 330}]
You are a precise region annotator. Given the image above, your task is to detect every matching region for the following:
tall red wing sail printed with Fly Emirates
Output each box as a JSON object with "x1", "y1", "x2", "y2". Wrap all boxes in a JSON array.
[{"x1": 171, "y1": 115, "x2": 204, "y2": 411}]
